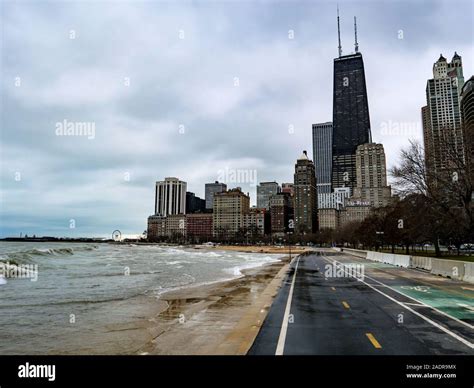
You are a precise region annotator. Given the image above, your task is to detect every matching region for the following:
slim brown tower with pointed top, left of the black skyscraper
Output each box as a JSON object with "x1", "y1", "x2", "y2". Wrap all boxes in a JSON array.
[{"x1": 294, "y1": 151, "x2": 318, "y2": 233}]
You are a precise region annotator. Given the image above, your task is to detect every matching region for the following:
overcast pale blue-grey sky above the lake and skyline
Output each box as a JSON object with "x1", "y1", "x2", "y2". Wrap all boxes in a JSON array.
[{"x1": 0, "y1": 0, "x2": 474, "y2": 237}]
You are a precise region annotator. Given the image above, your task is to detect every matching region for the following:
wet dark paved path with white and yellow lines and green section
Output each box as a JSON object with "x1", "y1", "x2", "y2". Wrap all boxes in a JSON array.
[{"x1": 249, "y1": 251, "x2": 474, "y2": 355}]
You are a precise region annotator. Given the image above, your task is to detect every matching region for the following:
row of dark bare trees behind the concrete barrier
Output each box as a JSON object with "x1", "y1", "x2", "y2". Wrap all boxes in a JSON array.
[{"x1": 326, "y1": 139, "x2": 474, "y2": 256}]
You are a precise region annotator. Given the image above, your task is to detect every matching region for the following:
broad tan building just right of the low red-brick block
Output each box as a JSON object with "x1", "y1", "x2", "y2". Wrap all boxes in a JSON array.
[{"x1": 213, "y1": 188, "x2": 250, "y2": 238}]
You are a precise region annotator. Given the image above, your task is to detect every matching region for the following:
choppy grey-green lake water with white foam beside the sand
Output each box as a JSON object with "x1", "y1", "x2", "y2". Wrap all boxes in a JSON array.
[{"x1": 0, "y1": 242, "x2": 281, "y2": 354}]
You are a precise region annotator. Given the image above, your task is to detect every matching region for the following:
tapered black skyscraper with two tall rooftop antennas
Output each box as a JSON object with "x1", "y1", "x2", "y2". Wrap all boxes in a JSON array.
[{"x1": 332, "y1": 15, "x2": 372, "y2": 192}]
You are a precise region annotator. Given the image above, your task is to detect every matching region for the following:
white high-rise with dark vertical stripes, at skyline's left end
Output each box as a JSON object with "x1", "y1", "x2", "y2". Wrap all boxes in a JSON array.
[{"x1": 155, "y1": 178, "x2": 186, "y2": 217}]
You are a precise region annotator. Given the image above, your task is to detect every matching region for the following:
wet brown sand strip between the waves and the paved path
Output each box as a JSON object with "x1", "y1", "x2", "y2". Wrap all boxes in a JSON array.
[{"x1": 135, "y1": 255, "x2": 289, "y2": 355}]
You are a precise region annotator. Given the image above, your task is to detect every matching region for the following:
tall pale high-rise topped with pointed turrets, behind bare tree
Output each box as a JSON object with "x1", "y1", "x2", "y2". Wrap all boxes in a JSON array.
[{"x1": 422, "y1": 53, "x2": 464, "y2": 177}]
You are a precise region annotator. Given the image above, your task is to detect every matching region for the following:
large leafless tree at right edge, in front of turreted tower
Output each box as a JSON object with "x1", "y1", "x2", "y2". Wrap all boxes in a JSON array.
[{"x1": 390, "y1": 136, "x2": 474, "y2": 255}]
